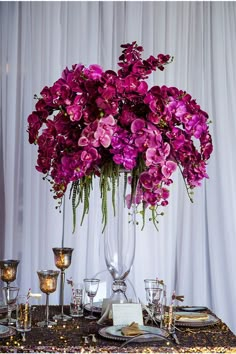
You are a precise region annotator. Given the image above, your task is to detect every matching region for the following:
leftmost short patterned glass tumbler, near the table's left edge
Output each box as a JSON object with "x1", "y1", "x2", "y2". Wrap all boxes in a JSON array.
[{"x1": 16, "y1": 295, "x2": 32, "y2": 333}]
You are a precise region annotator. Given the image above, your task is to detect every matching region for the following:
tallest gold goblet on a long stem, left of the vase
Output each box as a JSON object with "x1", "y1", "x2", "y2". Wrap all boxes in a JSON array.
[{"x1": 52, "y1": 247, "x2": 74, "y2": 321}]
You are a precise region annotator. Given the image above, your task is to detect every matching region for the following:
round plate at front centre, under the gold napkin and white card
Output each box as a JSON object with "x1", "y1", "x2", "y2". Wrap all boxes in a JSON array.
[{"x1": 98, "y1": 325, "x2": 168, "y2": 342}]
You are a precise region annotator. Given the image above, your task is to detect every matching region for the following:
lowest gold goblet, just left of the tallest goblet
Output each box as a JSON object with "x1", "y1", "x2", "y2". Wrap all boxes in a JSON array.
[{"x1": 37, "y1": 270, "x2": 60, "y2": 327}]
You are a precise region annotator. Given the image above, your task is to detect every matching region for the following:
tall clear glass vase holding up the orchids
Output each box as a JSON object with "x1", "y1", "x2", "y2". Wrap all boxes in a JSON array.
[{"x1": 104, "y1": 173, "x2": 136, "y2": 303}]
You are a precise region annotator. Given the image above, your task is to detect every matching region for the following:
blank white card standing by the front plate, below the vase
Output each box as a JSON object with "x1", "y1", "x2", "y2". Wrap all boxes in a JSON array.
[{"x1": 112, "y1": 303, "x2": 143, "y2": 326}]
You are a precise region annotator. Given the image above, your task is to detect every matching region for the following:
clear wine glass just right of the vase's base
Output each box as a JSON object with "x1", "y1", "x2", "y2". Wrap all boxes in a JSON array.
[{"x1": 144, "y1": 279, "x2": 162, "y2": 321}]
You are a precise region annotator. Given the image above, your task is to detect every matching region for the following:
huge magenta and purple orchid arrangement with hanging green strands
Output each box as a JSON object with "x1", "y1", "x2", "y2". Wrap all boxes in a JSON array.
[{"x1": 28, "y1": 42, "x2": 213, "y2": 232}]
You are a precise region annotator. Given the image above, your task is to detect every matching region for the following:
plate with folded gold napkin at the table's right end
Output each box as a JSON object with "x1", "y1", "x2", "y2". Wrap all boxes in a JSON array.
[{"x1": 175, "y1": 311, "x2": 219, "y2": 327}]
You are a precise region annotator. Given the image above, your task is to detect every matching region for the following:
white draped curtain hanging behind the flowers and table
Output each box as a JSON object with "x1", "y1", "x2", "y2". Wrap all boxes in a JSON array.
[{"x1": 0, "y1": 1, "x2": 236, "y2": 332}]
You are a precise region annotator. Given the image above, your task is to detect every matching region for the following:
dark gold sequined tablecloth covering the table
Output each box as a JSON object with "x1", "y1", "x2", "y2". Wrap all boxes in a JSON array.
[{"x1": 0, "y1": 306, "x2": 236, "y2": 353}]
